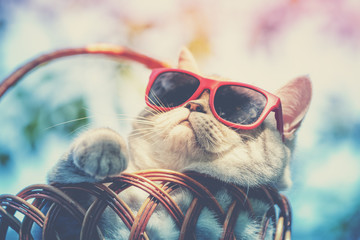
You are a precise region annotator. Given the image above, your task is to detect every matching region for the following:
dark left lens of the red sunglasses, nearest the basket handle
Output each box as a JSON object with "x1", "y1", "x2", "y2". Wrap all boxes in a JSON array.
[{"x1": 148, "y1": 72, "x2": 200, "y2": 108}]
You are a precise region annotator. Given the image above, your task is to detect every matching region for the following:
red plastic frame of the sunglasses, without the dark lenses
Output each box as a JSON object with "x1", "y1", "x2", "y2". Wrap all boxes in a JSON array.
[{"x1": 145, "y1": 68, "x2": 284, "y2": 140}]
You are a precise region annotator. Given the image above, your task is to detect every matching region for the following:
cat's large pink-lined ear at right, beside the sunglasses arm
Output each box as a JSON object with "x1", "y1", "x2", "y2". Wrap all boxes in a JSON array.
[{"x1": 276, "y1": 76, "x2": 312, "y2": 140}]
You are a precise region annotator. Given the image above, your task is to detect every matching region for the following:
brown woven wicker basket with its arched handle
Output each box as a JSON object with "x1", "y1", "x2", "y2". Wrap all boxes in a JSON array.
[{"x1": 0, "y1": 44, "x2": 291, "y2": 240}]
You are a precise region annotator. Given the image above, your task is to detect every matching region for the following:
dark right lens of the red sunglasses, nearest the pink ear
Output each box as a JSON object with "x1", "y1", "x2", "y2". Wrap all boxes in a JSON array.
[{"x1": 214, "y1": 85, "x2": 267, "y2": 125}]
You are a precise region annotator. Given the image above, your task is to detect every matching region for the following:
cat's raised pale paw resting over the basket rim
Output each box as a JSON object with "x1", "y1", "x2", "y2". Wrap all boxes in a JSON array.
[{"x1": 72, "y1": 128, "x2": 128, "y2": 178}]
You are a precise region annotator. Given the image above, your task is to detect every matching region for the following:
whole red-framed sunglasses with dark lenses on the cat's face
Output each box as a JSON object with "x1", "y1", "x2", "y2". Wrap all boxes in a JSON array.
[{"x1": 145, "y1": 68, "x2": 283, "y2": 139}]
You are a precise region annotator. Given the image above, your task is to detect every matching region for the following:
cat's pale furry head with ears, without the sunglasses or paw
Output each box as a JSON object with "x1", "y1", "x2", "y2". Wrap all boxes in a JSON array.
[{"x1": 129, "y1": 48, "x2": 311, "y2": 189}]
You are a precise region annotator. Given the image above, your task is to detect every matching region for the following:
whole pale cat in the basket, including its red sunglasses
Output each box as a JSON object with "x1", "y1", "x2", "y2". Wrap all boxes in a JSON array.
[{"x1": 44, "y1": 48, "x2": 311, "y2": 239}]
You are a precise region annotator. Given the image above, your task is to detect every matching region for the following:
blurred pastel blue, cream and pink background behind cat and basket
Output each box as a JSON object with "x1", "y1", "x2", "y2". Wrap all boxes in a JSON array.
[{"x1": 0, "y1": 0, "x2": 360, "y2": 239}]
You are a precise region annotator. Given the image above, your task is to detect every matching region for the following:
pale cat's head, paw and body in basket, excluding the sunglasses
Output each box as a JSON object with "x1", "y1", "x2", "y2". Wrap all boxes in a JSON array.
[{"x1": 43, "y1": 48, "x2": 311, "y2": 239}]
